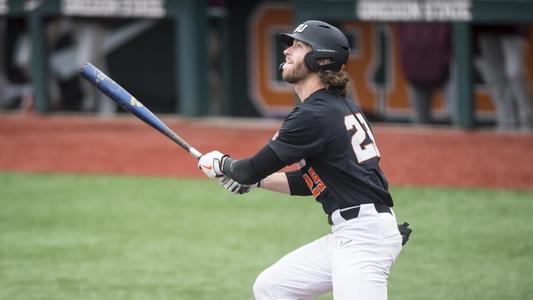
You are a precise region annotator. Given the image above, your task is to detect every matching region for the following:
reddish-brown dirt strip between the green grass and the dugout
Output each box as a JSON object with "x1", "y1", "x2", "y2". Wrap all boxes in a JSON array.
[{"x1": 0, "y1": 115, "x2": 533, "y2": 189}]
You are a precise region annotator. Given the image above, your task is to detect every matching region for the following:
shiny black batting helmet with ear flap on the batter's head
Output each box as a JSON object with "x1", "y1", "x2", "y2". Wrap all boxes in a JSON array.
[{"x1": 280, "y1": 20, "x2": 350, "y2": 72}]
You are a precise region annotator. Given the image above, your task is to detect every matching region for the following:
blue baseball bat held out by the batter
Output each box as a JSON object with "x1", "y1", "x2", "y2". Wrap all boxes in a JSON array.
[{"x1": 80, "y1": 63, "x2": 202, "y2": 159}]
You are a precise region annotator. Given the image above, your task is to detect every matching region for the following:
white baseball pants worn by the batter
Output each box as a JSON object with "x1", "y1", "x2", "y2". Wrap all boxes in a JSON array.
[{"x1": 254, "y1": 204, "x2": 402, "y2": 300}]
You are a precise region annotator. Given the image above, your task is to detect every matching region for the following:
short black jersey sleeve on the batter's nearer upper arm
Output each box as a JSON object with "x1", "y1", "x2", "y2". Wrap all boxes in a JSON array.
[{"x1": 269, "y1": 109, "x2": 325, "y2": 165}]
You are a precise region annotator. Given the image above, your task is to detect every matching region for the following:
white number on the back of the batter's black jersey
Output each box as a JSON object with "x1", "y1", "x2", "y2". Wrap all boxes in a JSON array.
[{"x1": 344, "y1": 113, "x2": 380, "y2": 164}]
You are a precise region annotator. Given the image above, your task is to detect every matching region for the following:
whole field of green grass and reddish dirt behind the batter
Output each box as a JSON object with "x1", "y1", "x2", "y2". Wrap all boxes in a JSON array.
[{"x1": 0, "y1": 115, "x2": 533, "y2": 300}]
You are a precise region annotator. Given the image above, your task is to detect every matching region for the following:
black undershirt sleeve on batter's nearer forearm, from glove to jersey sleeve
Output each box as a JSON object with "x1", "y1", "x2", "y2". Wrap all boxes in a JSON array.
[{"x1": 222, "y1": 145, "x2": 285, "y2": 184}]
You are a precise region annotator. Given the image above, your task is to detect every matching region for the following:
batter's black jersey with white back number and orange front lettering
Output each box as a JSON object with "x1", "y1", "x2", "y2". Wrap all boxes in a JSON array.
[{"x1": 269, "y1": 89, "x2": 393, "y2": 214}]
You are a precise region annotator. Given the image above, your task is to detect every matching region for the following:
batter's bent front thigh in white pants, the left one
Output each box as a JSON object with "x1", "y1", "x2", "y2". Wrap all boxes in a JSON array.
[{"x1": 254, "y1": 235, "x2": 332, "y2": 299}]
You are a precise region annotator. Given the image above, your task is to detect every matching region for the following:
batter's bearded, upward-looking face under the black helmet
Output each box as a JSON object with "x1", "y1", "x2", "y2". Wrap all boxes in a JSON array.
[{"x1": 281, "y1": 40, "x2": 312, "y2": 83}]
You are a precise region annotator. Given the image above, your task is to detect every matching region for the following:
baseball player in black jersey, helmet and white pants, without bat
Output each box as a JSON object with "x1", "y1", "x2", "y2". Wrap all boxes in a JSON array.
[{"x1": 198, "y1": 20, "x2": 410, "y2": 299}]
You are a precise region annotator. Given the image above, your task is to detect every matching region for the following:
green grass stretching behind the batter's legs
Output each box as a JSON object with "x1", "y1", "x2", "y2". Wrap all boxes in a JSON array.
[{"x1": 0, "y1": 173, "x2": 533, "y2": 300}]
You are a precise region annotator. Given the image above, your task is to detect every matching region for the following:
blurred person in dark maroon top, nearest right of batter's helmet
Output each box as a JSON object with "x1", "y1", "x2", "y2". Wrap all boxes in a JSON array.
[{"x1": 396, "y1": 23, "x2": 453, "y2": 123}]
